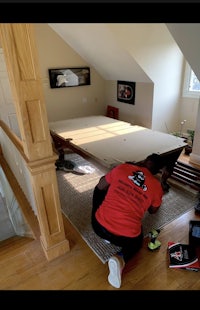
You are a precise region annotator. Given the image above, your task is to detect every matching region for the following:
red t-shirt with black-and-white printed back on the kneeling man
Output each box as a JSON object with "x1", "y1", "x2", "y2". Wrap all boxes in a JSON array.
[{"x1": 96, "y1": 163, "x2": 163, "y2": 237}]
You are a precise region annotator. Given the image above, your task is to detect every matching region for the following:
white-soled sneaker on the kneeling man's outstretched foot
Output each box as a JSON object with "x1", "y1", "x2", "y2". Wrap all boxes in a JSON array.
[{"x1": 108, "y1": 255, "x2": 125, "y2": 288}]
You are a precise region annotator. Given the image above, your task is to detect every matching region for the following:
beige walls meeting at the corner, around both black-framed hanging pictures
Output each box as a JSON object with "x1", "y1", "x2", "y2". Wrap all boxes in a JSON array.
[{"x1": 35, "y1": 24, "x2": 153, "y2": 128}]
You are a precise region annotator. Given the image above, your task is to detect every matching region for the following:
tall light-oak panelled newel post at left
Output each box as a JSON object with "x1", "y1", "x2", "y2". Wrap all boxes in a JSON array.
[{"x1": 0, "y1": 24, "x2": 69, "y2": 260}]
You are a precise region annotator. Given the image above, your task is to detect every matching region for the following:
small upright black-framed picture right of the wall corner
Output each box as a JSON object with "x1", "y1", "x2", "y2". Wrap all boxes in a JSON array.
[{"x1": 117, "y1": 81, "x2": 135, "y2": 104}]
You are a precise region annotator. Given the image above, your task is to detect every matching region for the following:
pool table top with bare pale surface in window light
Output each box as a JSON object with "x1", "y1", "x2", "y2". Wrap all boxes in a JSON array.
[{"x1": 49, "y1": 115, "x2": 186, "y2": 168}]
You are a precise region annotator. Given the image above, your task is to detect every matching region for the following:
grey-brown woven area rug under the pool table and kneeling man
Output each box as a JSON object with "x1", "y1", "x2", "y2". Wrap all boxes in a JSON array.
[{"x1": 57, "y1": 153, "x2": 197, "y2": 263}]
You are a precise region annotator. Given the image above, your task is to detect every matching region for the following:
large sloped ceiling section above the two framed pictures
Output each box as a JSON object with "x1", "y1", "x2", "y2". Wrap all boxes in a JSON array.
[{"x1": 49, "y1": 23, "x2": 152, "y2": 83}]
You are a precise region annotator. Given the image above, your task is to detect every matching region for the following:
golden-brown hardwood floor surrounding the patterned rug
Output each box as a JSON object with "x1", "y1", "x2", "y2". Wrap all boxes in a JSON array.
[{"x1": 0, "y1": 151, "x2": 200, "y2": 291}]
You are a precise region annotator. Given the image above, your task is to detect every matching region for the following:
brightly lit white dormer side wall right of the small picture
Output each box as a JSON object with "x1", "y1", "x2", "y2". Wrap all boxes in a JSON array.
[{"x1": 107, "y1": 24, "x2": 183, "y2": 132}]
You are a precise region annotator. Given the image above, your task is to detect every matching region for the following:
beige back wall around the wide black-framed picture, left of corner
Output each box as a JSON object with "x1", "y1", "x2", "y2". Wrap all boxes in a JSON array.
[{"x1": 35, "y1": 24, "x2": 106, "y2": 122}]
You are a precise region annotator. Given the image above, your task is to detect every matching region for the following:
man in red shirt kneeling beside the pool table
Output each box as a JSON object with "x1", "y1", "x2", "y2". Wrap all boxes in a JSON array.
[{"x1": 92, "y1": 154, "x2": 164, "y2": 288}]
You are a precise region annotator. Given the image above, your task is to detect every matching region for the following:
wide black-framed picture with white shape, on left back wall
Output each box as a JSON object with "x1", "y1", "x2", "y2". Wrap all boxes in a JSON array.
[{"x1": 49, "y1": 67, "x2": 90, "y2": 88}]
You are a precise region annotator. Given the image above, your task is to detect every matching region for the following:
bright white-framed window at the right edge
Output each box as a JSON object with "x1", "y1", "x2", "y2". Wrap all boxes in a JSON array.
[{"x1": 183, "y1": 63, "x2": 200, "y2": 98}]
